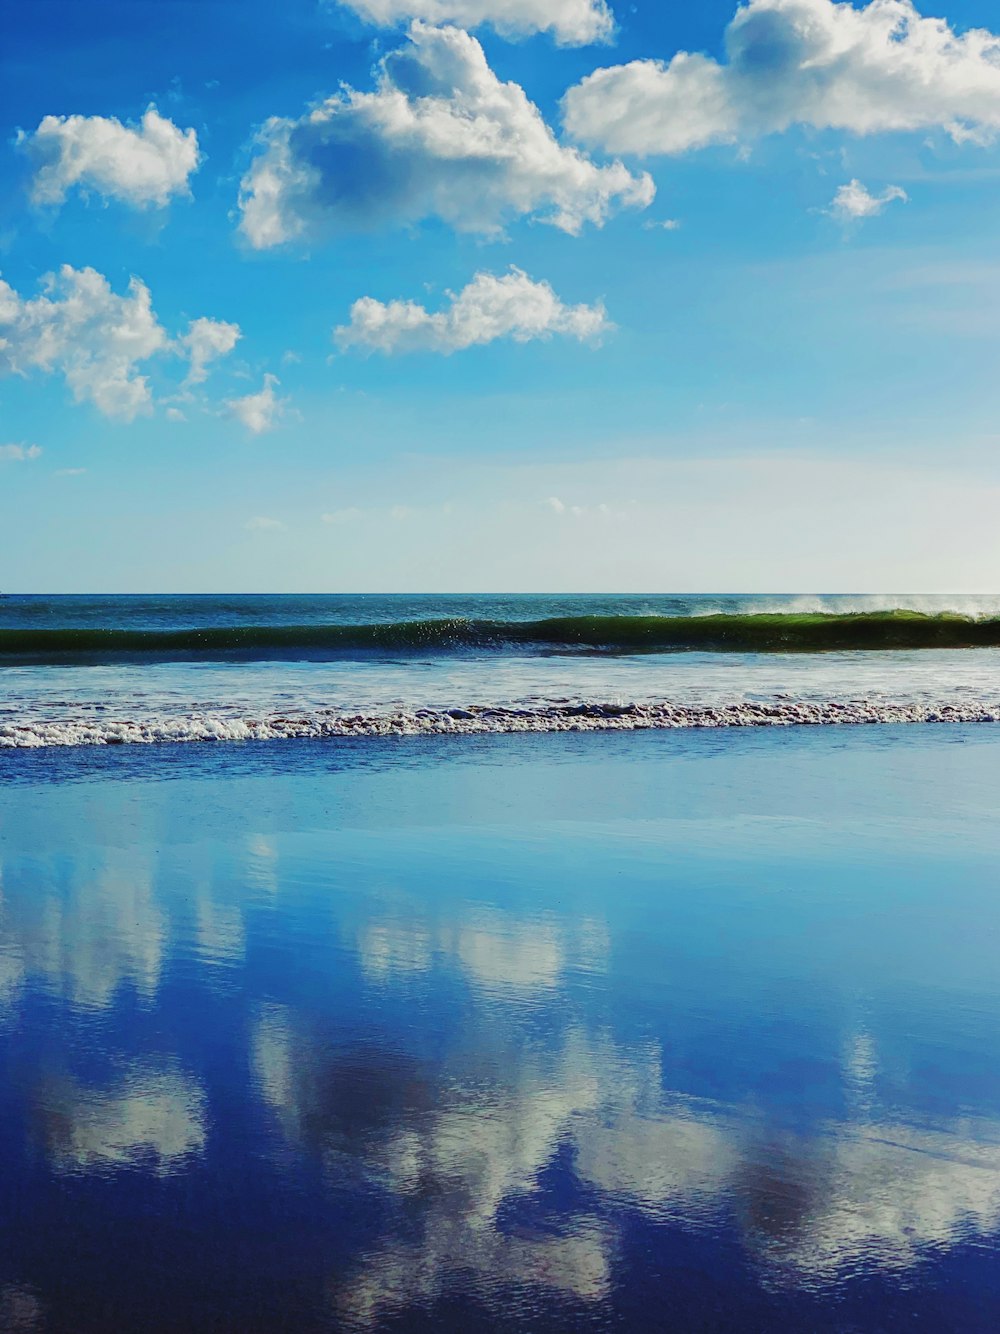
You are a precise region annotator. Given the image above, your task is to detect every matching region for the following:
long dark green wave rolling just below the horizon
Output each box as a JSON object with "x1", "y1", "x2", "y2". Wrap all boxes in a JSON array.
[{"x1": 0, "y1": 611, "x2": 1000, "y2": 662}]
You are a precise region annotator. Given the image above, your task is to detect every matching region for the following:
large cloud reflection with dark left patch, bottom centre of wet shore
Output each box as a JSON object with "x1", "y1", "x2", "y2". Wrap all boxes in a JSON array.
[{"x1": 253, "y1": 1009, "x2": 698, "y2": 1325}]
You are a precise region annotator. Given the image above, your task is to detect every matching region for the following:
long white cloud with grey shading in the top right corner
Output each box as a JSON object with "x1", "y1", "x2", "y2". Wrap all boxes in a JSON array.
[{"x1": 563, "y1": 0, "x2": 1000, "y2": 153}]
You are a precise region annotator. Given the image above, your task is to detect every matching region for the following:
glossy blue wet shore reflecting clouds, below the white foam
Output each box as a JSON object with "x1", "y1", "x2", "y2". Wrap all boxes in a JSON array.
[{"x1": 0, "y1": 727, "x2": 1000, "y2": 1334}]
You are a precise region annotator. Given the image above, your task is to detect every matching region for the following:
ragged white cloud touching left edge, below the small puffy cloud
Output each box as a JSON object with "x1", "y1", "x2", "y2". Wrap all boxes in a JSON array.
[{"x1": 0, "y1": 264, "x2": 239, "y2": 422}]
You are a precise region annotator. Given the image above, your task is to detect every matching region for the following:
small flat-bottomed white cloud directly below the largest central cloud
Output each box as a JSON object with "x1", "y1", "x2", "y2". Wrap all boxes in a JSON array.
[{"x1": 333, "y1": 268, "x2": 611, "y2": 352}]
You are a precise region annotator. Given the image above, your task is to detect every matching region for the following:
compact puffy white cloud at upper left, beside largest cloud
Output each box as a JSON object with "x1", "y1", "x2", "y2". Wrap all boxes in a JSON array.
[{"x1": 20, "y1": 107, "x2": 200, "y2": 208}]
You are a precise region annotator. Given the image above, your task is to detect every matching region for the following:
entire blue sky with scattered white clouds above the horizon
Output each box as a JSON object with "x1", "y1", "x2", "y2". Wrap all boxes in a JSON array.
[{"x1": 0, "y1": 0, "x2": 1000, "y2": 591}]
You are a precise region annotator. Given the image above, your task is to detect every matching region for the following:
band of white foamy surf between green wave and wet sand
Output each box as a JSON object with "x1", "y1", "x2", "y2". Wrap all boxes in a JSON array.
[{"x1": 0, "y1": 648, "x2": 1000, "y2": 748}]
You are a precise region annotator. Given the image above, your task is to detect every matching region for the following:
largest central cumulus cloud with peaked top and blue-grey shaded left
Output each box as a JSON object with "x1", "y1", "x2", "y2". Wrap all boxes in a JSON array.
[{"x1": 240, "y1": 23, "x2": 655, "y2": 249}]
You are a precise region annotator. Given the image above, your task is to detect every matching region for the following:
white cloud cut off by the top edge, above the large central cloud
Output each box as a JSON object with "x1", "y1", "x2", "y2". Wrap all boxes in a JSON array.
[{"x1": 343, "y1": 0, "x2": 615, "y2": 47}]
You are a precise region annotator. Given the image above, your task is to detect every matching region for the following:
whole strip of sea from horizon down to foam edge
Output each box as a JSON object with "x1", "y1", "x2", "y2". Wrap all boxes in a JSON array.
[{"x1": 0, "y1": 595, "x2": 1000, "y2": 748}]
